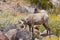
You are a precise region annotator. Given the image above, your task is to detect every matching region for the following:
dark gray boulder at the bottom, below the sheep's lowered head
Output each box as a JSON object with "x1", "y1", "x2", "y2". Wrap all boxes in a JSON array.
[{"x1": 16, "y1": 29, "x2": 31, "y2": 40}]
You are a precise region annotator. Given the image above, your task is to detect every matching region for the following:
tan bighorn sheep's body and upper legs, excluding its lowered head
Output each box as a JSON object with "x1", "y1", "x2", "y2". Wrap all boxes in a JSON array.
[{"x1": 21, "y1": 10, "x2": 50, "y2": 39}]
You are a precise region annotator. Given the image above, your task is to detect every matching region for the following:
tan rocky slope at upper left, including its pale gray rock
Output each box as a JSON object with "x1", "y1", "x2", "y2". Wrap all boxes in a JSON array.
[{"x1": 0, "y1": 0, "x2": 34, "y2": 14}]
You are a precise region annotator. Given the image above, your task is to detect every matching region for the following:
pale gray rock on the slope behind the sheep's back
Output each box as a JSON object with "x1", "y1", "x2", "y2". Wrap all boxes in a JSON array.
[{"x1": 15, "y1": 6, "x2": 35, "y2": 13}]
